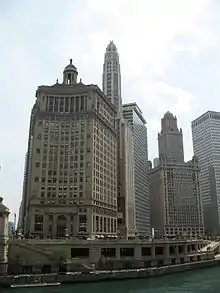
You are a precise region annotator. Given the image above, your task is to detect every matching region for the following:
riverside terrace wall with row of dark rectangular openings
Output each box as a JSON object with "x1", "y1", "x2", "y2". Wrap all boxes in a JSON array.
[{"x1": 9, "y1": 239, "x2": 214, "y2": 268}]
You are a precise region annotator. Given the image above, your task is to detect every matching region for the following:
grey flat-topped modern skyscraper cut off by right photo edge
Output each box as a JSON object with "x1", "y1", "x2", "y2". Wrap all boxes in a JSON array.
[{"x1": 191, "y1": 111, "x2": 220, "y2": 235}]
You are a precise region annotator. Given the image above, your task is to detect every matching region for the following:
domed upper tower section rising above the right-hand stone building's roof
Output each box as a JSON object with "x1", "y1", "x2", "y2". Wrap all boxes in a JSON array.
[{"x1": 158, "y1": 111, "x2": 184, "y2": 163}]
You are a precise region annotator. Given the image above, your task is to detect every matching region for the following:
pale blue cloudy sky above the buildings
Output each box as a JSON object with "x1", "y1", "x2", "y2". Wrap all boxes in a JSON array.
[{"x1": 0, "y1": 0, "x2": 220, "y2": 218}]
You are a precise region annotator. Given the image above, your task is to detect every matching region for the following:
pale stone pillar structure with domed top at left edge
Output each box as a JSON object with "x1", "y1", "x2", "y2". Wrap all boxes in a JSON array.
[{"x1": 0, "y1": 197, "x2": 9, "y2": 275}]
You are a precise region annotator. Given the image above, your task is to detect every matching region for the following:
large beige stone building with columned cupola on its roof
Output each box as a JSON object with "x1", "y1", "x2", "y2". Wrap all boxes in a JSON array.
[{"x1": 23, "y1": 60, "x2": 117, "y2": 239}]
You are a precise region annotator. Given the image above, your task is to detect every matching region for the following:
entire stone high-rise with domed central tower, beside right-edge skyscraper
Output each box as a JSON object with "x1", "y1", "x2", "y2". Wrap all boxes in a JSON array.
[{"x1": 149, "y1": 112, "x2": 204, "y2": 237}]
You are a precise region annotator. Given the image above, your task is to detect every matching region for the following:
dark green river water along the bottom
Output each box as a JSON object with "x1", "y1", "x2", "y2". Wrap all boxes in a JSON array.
[{"x1": 0, "y1": 267, "x2": 220, "y2": 293}]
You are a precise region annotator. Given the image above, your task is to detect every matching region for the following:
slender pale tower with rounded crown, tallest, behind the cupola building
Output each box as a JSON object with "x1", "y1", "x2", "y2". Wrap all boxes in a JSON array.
[{"x1": 102, "y1": 41, "x2": 122, "y2": 117}]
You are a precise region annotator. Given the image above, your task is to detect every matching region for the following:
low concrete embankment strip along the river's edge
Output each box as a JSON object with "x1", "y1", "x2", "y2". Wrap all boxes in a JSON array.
[{"x1": 0, "y1": 259, "x2": 220, "y2": 286}]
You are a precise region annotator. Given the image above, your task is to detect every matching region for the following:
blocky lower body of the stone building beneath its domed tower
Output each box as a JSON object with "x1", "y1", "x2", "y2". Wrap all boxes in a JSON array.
[{"x1": 149, "y1": 157, "x2": 204, "y2": 238}]
